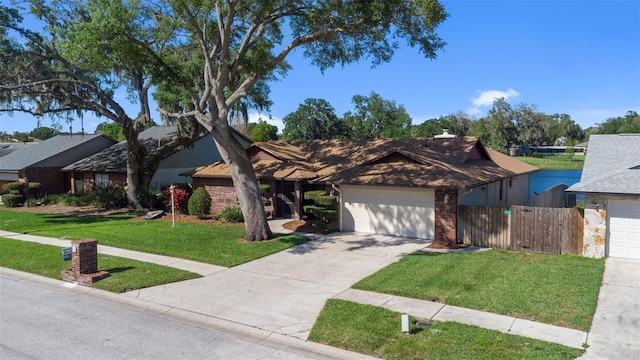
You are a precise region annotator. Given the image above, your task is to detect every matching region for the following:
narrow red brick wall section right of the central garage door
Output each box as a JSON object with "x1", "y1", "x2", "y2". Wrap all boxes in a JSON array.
[{"x1": 435, "y1": 189, "x2": 458, "y2": 246}]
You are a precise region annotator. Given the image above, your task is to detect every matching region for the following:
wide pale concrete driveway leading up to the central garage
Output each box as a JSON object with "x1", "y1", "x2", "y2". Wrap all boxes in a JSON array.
[{"x1": 123, "y1": 233, "x2": 431, "y2": 339}]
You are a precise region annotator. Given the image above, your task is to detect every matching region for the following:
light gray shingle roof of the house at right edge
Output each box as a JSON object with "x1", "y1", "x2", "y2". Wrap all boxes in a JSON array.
[{"x1": 567, "y1": 134, "x2": 640, "y2": 194}]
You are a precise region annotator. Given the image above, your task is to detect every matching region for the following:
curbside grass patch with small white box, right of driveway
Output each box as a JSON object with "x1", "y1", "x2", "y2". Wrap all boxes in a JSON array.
[{"x1": 309, "y1": 299, "x2": 583, "y2": 360}]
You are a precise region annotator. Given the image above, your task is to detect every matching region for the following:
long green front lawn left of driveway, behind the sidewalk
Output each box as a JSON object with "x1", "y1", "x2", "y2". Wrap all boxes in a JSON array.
[{"x1": 0, "y1": 210, "x2": 308, "y2": 267}]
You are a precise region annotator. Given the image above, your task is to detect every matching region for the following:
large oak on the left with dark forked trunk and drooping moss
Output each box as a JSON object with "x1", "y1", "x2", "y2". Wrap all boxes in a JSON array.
[{"x1": 0, "y1": 0, "x2": 198, "y2": 208}]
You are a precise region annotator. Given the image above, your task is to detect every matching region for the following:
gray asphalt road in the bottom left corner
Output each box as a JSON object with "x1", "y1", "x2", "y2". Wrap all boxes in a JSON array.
[{"x1": 0, "y1": 277, "x2": 322, "y2": 360}]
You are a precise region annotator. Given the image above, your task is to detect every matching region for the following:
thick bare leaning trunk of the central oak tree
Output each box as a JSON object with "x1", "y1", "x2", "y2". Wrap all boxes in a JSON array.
[{"x1": 211, "y1": 126, "x2": 273, "y2": 241}]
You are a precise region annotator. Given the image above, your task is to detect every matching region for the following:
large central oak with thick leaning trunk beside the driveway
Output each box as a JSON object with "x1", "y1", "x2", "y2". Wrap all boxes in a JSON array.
[{"x1": 3, "y1": 0, "x2": 447, "y2": 241}]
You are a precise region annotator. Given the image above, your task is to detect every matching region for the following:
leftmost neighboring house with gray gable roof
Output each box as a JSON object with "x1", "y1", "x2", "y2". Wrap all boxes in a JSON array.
[{"x1": 0, "y1": 134, "x2": 115, "y2": 194}]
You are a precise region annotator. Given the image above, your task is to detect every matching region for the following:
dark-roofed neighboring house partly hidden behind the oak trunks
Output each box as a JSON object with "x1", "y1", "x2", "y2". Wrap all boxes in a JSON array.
[{"x1": 63, "y1": 126, "x2": 251, "y2": 194}]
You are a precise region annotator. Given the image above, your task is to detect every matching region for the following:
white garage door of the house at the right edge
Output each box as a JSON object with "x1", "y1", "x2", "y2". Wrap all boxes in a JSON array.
[{"x1": 607, "y1": 200, "x2": 640, "y2": 260}]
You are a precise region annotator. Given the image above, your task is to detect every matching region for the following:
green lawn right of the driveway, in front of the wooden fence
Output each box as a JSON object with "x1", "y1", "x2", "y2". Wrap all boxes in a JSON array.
[{"x1": 354, "y1": 249, "x2": 604, "y2": 331}]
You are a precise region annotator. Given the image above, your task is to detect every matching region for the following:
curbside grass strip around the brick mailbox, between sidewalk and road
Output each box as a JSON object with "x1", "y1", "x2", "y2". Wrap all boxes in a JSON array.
[{"x1": 0, "y1": 238, "x2": 200, "y2": 293}]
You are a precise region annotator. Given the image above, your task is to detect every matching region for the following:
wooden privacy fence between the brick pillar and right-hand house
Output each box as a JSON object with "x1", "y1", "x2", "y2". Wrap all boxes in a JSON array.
[{"x1": 458, "y1": 206, "x2": 584, "y2": 255}]
